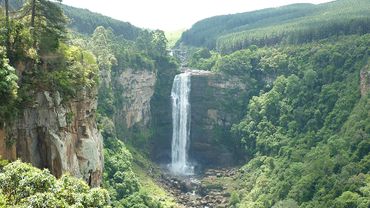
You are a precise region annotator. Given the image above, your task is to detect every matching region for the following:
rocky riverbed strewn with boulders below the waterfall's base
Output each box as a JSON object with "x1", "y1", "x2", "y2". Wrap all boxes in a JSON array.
[{"x1": 159, "y1": 169, "x2": 238, "y2": 208}]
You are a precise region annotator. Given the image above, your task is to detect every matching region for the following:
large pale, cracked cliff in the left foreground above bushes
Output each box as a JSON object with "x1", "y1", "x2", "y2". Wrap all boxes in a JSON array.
[{"x1": 11, "y1": 90, "x2": 104, "y2": 186}]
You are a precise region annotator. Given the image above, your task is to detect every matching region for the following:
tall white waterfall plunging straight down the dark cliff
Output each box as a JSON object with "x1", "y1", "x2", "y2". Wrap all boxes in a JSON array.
[{"x1": 170, "y1": 72, "x2": 194, "y2": 175}]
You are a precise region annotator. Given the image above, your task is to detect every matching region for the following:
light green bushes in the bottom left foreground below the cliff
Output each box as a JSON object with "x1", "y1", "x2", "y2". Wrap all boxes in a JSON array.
[{"x1": 0, "y1": 161, "x2": 110, "y2": 208}]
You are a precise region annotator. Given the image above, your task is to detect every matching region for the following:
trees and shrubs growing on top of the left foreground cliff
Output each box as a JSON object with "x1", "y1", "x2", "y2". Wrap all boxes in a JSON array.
[{"x1": 0, "y1": 0, "x2": 98, "y2": 105}]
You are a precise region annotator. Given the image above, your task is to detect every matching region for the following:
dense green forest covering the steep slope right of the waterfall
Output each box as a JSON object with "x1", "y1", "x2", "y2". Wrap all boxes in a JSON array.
[{"x1": 188, "y1": 35, "x2": 370, "y2": 207}]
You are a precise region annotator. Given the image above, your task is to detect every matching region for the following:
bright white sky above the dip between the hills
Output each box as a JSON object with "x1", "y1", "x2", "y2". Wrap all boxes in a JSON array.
[{"x1": 63, "y1": 0, "x2": 331, "y2": 31}]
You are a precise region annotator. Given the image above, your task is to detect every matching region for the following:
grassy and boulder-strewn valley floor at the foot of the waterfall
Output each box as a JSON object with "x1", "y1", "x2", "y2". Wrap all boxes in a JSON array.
[{"x1": 130, "y1": 148, "x2": 240, "y2": 208}]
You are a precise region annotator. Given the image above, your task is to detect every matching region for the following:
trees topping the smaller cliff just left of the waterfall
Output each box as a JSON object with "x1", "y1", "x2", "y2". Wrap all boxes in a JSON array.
[{"x1": 84, "y1": 27, "x2": 168, "y2": 72}]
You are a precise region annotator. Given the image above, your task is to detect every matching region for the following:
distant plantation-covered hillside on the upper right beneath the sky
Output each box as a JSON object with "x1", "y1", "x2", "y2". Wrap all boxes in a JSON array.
[{"x1": 179, "y1": 0, "x2": 370, "y2": 53}]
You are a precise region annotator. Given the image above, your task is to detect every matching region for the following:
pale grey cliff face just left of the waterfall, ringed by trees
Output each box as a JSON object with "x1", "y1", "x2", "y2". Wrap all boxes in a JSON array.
[{"x1": 114, "y1": 69, "x2": 156, "y2": 138}]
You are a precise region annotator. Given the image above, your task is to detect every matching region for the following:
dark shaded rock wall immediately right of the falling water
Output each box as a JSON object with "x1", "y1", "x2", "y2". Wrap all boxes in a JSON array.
[{"x1": 189, "y1": 71, "x2": 248, "y2": 167}]
